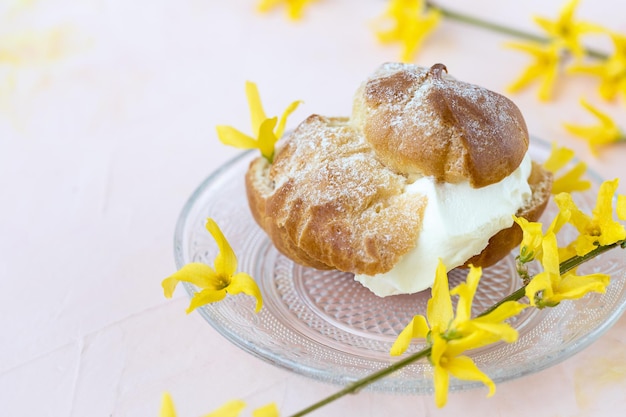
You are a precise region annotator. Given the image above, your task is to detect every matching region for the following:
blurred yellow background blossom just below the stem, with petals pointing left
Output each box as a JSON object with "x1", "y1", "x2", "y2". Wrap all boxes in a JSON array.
[{"x1": 505, "y1": 42, "x2": 562, "y2": 101}]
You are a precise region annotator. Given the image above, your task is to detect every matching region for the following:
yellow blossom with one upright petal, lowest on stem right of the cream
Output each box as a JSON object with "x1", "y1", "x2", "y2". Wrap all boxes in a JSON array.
[{"x1": 526, "y1": 232, "x2": 610, "y2": 308}]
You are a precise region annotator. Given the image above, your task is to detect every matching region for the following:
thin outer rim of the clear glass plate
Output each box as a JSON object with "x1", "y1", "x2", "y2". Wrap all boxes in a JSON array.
[{"x1": 174, "y1": 137, "x2": 626, "y2": 394}]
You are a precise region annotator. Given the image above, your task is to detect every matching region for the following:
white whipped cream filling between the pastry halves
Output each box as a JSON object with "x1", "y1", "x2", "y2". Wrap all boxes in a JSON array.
[{"x1": 354, "y1": 154, "x2": 532, "y2": 297}]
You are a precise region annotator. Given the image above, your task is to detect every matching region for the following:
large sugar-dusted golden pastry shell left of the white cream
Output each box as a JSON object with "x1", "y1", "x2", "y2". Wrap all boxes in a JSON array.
[{"x1": 246, "y1": 115, "x2": 425, "y2": 275}]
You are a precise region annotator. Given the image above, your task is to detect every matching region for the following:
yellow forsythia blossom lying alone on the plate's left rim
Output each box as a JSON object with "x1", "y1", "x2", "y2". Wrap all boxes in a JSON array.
[{"x1": 162, "y1": 219, "x2": 263, "y2": 313}]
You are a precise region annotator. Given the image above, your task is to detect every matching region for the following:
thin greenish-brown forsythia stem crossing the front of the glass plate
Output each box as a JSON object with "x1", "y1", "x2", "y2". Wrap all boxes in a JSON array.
[{"x1": 291, "y1": 239, "x2": 626, "y2": 417}]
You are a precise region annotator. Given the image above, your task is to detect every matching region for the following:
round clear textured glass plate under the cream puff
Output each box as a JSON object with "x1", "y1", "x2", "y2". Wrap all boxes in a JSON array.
[{"x1": 175, "y1": 139, "x2": 626, "y2": 393}]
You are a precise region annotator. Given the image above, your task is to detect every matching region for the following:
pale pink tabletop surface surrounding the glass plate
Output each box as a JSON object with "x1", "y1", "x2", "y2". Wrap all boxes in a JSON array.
[{"x1": 0, "y1": 0, "x2": 626, "y2": 417}]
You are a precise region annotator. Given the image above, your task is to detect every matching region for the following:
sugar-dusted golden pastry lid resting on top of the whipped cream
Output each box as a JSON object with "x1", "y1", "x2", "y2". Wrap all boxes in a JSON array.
[{"x1": 353, "y1": 64, "x2": 528, "y2": 188}]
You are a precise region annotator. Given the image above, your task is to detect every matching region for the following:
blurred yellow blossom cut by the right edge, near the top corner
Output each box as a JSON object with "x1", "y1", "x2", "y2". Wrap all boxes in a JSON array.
[{"x1": 569, "y1": 32, "x2": 626, "y2": 100}]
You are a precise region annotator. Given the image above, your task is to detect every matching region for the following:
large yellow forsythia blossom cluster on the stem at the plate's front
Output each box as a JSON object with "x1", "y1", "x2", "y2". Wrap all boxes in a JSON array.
[{"x1": 390, "y1": 260, "x2": 526, "y2": 407}]
